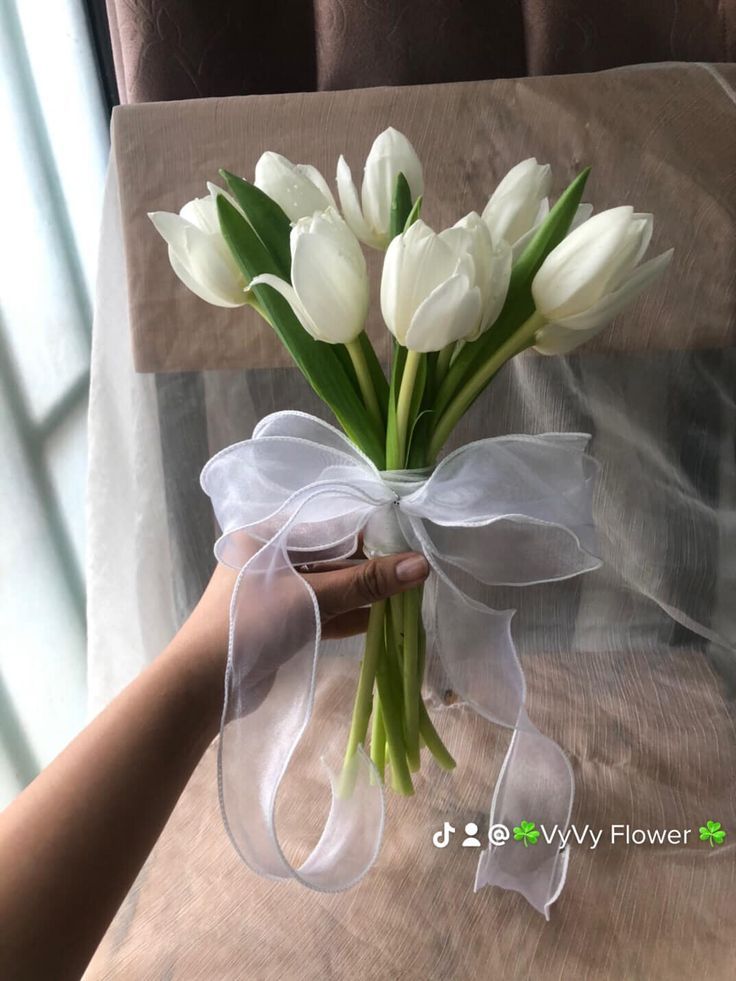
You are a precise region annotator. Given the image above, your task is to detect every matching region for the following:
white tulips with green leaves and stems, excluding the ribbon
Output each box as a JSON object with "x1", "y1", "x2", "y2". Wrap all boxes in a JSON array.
[{"x1": 150, "y1": 128, "x2": 671, "y2": 794}]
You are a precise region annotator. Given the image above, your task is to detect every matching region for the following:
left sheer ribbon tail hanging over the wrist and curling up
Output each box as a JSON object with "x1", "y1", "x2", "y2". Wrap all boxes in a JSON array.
[{"x1": 218, "y1": 526, "x2": 384, "y2": 892}]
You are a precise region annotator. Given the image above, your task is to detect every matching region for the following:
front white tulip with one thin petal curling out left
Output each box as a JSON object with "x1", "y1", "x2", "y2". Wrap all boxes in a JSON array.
[{"x1": 251, "y1": 208, "x2": 368, "y2": 344}]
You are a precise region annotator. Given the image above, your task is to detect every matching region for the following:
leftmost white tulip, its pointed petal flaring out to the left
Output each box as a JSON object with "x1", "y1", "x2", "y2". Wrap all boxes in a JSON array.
[{"x1": 148, "y1": 184, "x2": 248, "y2": 307}]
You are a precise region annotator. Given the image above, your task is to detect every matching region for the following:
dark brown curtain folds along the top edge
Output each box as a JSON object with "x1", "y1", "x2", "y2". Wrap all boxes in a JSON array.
[{"x1": 107, "y1": 0, "x2": 736, "y2": 102}]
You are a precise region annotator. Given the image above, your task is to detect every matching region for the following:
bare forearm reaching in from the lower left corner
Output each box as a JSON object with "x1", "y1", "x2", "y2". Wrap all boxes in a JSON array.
[{"x1": 0, "y1": 622, "x2": 224, "y2": 981}]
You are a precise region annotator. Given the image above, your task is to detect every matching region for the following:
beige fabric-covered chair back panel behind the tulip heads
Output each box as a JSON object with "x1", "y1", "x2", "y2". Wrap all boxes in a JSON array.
[{"x1": 113, "y1": 64, "x2": 736, "y2": 371}]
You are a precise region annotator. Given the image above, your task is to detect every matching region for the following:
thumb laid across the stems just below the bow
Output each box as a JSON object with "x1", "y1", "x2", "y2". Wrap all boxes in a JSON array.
[{"x1": 304, "y1": 552, "x2": 429, "y2": 618}]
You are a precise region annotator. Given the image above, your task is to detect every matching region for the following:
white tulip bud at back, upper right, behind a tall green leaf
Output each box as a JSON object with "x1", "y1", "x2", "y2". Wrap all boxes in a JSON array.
[{"x1": 483, "y1": 157, "x2": 552, "y2": 258}]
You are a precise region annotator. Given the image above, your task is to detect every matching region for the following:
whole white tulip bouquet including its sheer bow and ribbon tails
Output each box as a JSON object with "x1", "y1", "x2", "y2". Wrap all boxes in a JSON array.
[{"x1": 150, "y1": 128, "x2": 671, "y2": 914}]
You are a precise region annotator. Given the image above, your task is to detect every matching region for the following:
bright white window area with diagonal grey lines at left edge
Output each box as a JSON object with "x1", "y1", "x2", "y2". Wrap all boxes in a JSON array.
[{"x1": 0, "y1": 0, "x2": 108, "y2": 806}]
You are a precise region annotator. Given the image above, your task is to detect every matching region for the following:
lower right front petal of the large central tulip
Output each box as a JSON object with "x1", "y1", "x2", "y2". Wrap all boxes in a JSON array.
[{"x1": 405, "y1": 275, "x2": 481, "y2": 353}]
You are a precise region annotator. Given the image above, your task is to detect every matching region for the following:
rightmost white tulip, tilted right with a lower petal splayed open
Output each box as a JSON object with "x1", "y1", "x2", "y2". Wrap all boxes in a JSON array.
[{"x1": 532, "y1": 206, "x2": 673, "y2": 354}]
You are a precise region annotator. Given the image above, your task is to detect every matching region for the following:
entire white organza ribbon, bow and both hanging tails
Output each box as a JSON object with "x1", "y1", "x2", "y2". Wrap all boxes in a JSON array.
[{"x1": 202, "y1": 412, "x2": 600, "y2": 916}]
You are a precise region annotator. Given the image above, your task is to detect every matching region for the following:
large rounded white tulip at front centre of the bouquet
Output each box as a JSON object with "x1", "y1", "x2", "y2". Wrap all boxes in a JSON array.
[{"x1": 381, "y1": 220, "x2": 483, "y2": 353}]
